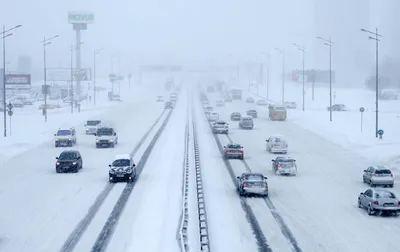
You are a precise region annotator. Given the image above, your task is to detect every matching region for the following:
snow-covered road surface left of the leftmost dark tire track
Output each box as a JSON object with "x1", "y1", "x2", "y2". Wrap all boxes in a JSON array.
[{"x1": 0, "y1": 102, "x2": 163, "y2": 251}]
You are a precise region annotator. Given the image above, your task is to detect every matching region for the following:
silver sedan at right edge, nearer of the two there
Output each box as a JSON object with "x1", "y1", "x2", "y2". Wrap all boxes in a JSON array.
[{"x1": 358, "y1": 189, "x2": 400, "y2": 216}]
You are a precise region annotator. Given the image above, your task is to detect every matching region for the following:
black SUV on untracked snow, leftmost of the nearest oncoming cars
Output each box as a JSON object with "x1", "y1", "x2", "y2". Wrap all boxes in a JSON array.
[{"x1": 56, "y1": 150, "x2": 83, "y2": 173}]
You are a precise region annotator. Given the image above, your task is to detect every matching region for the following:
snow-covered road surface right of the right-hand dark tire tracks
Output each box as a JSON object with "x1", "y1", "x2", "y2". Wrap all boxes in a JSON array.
[{"x1": 222, "y1": 105, "x2": 400, "y2": 251}]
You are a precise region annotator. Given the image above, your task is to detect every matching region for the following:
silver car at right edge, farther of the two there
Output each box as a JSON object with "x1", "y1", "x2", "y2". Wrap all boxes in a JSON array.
[{"x1": 363, "y1": 165, "x2": 394, "y2": 187}]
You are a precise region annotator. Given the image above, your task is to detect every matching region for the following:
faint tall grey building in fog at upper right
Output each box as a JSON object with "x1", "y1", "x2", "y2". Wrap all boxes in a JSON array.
[{"x1": 314, "y1": 0, "x2": 372, "y2": 86}]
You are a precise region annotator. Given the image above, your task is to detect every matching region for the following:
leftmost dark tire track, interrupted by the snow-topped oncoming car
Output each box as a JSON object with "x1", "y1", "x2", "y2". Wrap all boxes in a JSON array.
[{"x1": 59, "y1": 110, "x2": 168, "y2": 252}]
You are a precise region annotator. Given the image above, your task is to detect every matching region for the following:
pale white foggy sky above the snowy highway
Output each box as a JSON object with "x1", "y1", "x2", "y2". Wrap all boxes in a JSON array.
[{"x1": 0, "y1": 0, "x2": 394, "y2": 82}]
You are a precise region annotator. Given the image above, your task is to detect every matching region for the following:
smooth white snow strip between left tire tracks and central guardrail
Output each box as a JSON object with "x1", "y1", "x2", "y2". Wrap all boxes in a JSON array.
[{"x1": 108, "y1": 89, "x2": 187, "y2": 252}]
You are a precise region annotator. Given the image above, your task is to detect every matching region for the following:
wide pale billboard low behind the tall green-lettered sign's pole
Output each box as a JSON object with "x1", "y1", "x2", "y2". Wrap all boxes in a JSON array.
[{"x1": 46, "y1": 68, "x2": 92, "y2": 81}]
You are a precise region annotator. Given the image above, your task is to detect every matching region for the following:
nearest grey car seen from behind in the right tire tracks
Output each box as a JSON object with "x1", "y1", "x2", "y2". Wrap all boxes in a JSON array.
[{"x1": 236, "y1": 172, "x2": 268, "y2": 197}]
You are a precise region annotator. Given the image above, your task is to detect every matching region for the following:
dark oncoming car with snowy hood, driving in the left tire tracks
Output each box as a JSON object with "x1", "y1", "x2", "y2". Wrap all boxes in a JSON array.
[{"x1": 108, "y1": 154, "x2": 136, "y2": 183}]
